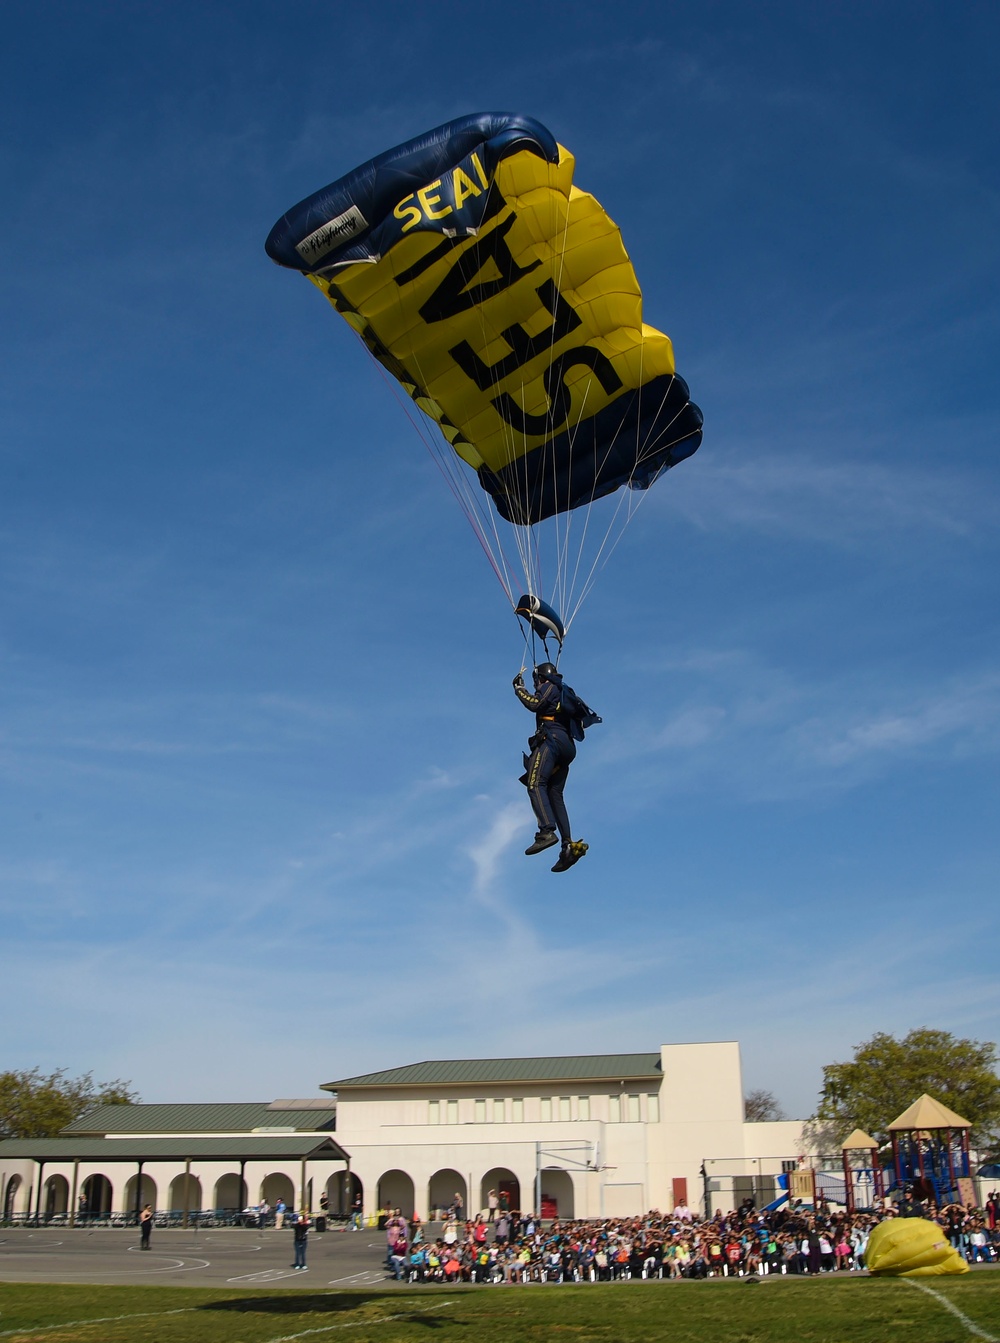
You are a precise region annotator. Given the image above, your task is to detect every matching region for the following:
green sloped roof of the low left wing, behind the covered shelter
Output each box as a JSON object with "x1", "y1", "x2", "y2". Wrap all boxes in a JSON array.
[{"x1": 63, "y1": 1099, "x2": 337, "y2": 1136}]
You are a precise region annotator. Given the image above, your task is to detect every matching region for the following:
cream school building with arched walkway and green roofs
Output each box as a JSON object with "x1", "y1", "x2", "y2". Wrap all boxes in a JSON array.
[{"x1": 0, "y1": 1041, "x2": 804, "y2": 1219}]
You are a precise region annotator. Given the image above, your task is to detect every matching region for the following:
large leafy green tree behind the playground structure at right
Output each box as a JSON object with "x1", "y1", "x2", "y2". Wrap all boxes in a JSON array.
[{"x1": 811, "y1": 1026, "x2": 1000, "y2": 1147}]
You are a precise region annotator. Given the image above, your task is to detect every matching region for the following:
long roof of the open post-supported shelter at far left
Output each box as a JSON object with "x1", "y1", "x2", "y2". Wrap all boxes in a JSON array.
[{"x1": 0, "y1": 1133, "x2": 348, "y2": 1162}]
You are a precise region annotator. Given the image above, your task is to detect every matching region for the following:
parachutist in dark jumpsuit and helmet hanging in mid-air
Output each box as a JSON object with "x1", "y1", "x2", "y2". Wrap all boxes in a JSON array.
[{"x1": 514, "y1": 662, "x2": 601, "y2": 872}]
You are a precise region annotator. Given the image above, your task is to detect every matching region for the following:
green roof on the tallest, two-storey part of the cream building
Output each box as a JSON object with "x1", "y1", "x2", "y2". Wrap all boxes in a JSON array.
[{"x1": 322, "y1": 1052, "x2": 663, "y2": 1092}]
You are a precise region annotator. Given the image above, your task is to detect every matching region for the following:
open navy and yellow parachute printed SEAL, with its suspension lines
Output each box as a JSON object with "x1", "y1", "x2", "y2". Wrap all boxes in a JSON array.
[{"x1": 266, "y1": 113, "x2": 702, "y2": 645}]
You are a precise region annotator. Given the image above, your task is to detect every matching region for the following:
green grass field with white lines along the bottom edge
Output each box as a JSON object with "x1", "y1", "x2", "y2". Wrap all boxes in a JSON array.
[{"x1": 0, "y1": 1273, "x2": 1000, "y2": 1343}]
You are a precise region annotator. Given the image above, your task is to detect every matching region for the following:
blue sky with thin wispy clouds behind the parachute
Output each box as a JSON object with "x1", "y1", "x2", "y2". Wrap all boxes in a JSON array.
[{"x1": 0, "y1": 0, "x2": 1000, "y2": 1115}]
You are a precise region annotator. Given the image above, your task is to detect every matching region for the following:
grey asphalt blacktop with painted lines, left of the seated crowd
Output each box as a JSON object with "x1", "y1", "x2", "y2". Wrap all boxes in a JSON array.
[{"x1": 0, "y1": 1226, "x2": 389, "y2": 1291}]
